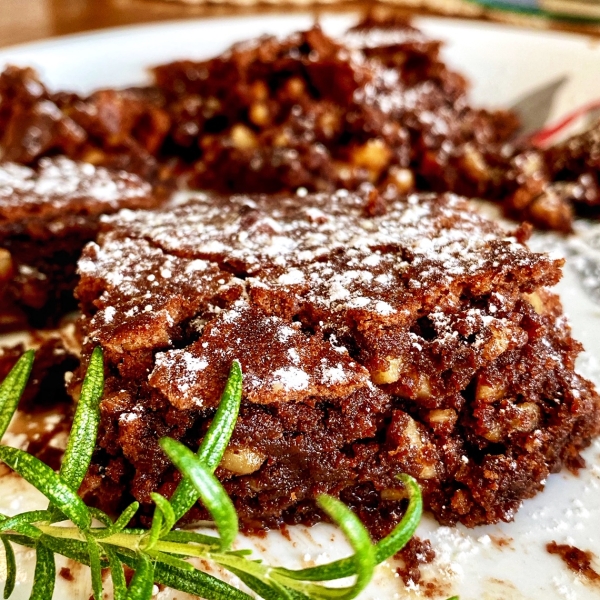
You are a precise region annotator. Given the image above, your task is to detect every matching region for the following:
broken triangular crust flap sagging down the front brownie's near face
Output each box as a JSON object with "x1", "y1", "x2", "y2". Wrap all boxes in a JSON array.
[{"x1": 149, "y1": 301, "x2": 369, "y2": 409}]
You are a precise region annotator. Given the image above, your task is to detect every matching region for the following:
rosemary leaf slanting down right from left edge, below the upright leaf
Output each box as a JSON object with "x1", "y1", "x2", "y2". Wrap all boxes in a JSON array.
[{"x1": 0, "y1": 446, "x2": 92, "y2": 530}]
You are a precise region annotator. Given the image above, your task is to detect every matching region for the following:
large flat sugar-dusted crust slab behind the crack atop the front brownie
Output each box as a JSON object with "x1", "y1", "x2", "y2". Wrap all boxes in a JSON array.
[{"x1": 99, "y1": 190, "x2": 547, "y2": 338}]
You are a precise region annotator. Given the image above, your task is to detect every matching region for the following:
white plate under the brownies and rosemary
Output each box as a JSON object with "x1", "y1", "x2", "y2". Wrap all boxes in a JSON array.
[{"x1": 0, "y1": 15, "x2": 600, "y2": 600}]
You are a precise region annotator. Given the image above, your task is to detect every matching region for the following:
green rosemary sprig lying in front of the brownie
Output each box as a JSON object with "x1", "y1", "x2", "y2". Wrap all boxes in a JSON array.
[{"x1": 0, "y1": 348, "x2": 432, "y2": 600}]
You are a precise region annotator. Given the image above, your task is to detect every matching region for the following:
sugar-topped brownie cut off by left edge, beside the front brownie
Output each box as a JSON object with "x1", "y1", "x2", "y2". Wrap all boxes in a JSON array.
[{"x1": 0, "y1": 157, "x2": 161, "y2": 329}]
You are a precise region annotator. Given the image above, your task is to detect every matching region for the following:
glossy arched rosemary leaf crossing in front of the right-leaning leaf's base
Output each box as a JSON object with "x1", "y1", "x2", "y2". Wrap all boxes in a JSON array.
[{"x1": 159, "y1": 438, "x2": 238, "y2": 550}]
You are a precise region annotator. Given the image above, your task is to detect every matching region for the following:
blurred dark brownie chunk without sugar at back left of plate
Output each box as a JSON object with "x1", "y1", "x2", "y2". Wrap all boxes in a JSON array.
[{"x1": 0, "y1": 66, "x2": 169, "y2": 180}]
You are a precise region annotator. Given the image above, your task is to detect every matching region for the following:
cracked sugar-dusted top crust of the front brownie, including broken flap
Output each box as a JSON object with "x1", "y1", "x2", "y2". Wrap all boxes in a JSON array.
[{"x1": 79, "y1": 189, "x2": 558, "y2": 408}]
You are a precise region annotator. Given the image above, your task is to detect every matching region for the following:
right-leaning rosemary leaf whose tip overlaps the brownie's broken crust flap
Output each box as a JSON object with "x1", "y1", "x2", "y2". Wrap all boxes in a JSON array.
[{"x1": 171, "y1": 360, "x2": 242, "y2": 520}]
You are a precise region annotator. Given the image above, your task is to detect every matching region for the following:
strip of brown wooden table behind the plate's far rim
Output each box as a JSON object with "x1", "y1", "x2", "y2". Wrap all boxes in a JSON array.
[{"x1": 0, "y1": 0, "x2": 600, "y2": 46}]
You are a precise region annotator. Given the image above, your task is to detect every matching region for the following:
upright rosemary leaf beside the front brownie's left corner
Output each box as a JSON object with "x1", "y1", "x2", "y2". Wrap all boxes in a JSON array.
[{"x1": 60, "y1": 347, "x2": 104, "y2": 492}]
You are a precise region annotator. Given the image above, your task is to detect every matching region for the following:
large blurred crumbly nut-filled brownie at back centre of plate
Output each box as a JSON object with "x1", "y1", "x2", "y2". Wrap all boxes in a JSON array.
[{"x1": 154, "y1": 21, "x2": 517, "y2": 199}]
